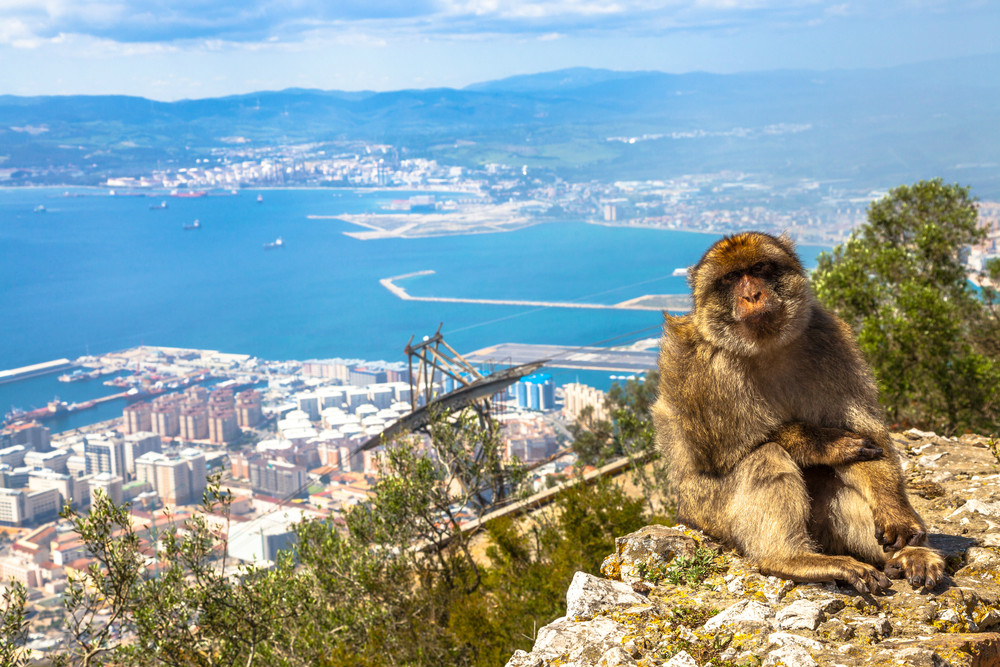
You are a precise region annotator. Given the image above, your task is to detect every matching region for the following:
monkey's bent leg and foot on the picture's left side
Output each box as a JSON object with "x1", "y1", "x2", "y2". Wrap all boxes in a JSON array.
[{"x1": 722, "y1": 442, "x2": 889, "y2": 593}]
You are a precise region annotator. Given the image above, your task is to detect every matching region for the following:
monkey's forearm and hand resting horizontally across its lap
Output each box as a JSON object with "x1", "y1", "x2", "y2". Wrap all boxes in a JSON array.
[{"x1": 769, "y1": 422, "x2": 882, "y2": 467}]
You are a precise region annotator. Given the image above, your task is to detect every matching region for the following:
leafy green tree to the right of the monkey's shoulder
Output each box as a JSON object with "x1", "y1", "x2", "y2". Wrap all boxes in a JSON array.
[{"x1": 813, "y1": 179, "x2": 1000, "y2": 433}]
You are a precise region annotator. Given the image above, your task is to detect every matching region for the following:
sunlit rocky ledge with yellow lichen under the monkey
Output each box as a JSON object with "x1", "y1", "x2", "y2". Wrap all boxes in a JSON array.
[{"x1": 507, "y1": 431, "x2": 1000, "y2": 667}]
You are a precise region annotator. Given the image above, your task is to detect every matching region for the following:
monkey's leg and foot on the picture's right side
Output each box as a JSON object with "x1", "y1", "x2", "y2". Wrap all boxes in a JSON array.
[{"x1": 803, "y1": 466, "x2": 944, "y2": 590}]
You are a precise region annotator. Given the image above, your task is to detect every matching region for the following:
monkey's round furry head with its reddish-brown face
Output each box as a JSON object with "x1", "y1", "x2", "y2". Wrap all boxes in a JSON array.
[{"x1": 691, "y1": 232, "x2": 812, "y2": 356}]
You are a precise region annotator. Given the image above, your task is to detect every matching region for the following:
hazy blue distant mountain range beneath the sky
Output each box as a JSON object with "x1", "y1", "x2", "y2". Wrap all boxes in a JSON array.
[{"x1": 0, "y1": 55, "x2": 1000, "y2": 197}]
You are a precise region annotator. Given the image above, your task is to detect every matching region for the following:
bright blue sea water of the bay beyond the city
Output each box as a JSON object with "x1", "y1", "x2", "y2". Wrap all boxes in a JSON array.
[{"x1": 0, "y1": 188, "x2": 818, "y2": 430}]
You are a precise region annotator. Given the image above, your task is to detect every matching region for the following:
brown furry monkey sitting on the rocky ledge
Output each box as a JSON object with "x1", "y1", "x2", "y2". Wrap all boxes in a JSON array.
[{"x1": 652, "y1": 232, "x2": 944, "y2": 594}]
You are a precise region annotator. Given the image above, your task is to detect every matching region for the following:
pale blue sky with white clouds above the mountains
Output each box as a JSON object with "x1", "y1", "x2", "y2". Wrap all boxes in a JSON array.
[{"x1": 0, "y1": 0, "x2": 1000, "y2": 101}]
